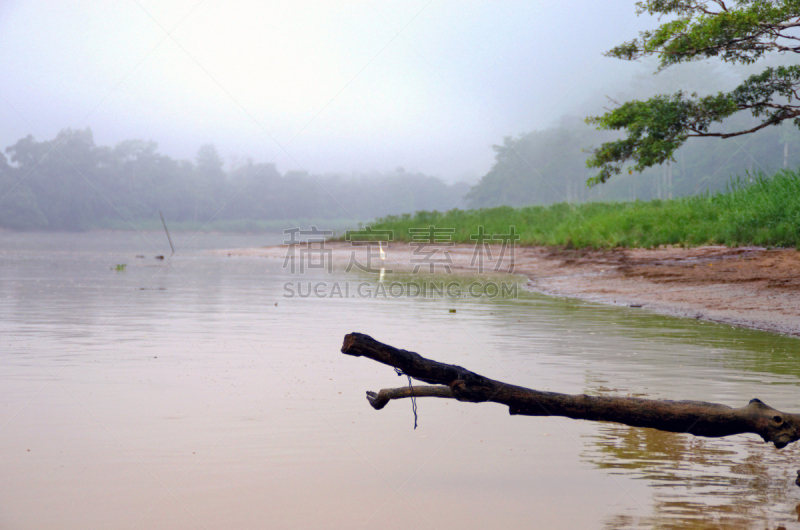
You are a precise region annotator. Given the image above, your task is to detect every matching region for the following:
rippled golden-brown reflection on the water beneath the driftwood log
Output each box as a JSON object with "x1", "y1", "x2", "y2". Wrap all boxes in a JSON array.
[{"x1": 583, "y1": 414, "x2": 800, "y2": 529}]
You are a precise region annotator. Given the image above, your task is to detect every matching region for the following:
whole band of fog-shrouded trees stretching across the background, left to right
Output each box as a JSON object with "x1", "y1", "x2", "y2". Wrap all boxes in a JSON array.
[{"x1": 0, "y1": 108, "x2": 800, "y2": 230}]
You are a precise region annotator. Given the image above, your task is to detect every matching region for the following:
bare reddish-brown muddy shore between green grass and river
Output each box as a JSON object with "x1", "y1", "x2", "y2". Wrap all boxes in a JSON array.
[{"x1": 215, "y1": 243, "x2": 800, "y2": 335}]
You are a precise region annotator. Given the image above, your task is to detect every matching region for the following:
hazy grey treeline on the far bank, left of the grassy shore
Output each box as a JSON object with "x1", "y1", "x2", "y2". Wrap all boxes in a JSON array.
[{"x1": 0, "y1": 128, "x2": 469, "y2": 230}]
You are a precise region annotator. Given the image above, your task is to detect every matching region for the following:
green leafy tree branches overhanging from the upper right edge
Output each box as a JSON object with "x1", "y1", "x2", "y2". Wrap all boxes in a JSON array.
[{"x1": 587, "y1": 0, "x2": 800, "y2": 184}]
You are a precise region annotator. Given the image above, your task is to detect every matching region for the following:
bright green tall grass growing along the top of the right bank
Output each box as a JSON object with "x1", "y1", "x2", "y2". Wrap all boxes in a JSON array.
[{"x1": 370, "y1": 169, "x2": 800, "y2": 248}]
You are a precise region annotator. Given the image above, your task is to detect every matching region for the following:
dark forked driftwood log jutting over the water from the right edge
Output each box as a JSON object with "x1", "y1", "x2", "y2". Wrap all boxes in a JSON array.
[{"x1": 342, "y1": 333, "x2": 800, "y2": 448}]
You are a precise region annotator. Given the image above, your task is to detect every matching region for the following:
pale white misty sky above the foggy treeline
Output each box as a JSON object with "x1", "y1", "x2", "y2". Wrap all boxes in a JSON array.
[{"x1": 0, "y1": 0, "x2": 656, "y2": 179}]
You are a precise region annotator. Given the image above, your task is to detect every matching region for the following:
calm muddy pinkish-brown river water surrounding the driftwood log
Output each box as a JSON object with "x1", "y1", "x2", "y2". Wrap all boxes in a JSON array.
[{"x1": 0, "y1": 232, "x2": 800, "y2": 530}]
